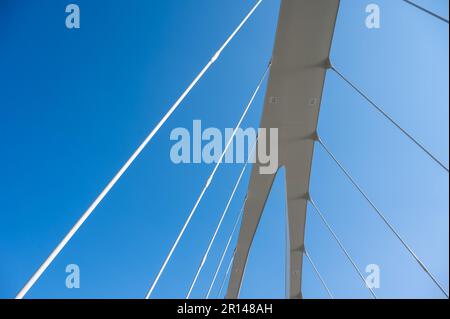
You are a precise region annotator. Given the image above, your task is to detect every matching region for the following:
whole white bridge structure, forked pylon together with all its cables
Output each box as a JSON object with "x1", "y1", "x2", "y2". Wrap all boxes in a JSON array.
[{"x1": 16, "y1": 0, "x2": 449, "y2": 299}]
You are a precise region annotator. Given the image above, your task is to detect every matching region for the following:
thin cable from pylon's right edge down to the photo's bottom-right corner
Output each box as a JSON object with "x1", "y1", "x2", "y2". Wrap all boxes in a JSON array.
[{"x1": 318, "y1": 137, "x2": 448, "y2": 298}]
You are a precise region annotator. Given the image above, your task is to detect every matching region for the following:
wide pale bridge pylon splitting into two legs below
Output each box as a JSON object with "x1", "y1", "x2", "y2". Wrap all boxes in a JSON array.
[{"x1": 226, "y1": 0, "x2": 339, "y2": 299}]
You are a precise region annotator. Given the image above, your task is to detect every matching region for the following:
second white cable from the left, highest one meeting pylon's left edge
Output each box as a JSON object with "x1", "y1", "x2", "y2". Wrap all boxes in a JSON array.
[{"x1": 145, "y1": 64, "x2": 271, "y2": 299}]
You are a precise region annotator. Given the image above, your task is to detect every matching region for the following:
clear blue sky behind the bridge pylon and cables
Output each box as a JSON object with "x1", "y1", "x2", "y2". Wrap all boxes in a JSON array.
[{"x1": 0, "y1": 0, "x2": 449, "y2": 298}]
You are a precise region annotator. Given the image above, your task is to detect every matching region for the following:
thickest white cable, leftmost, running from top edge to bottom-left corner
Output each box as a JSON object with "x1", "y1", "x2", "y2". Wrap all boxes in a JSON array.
[{"x1": 16, "y1": 0, "x2": 262, "y2": 299}]
